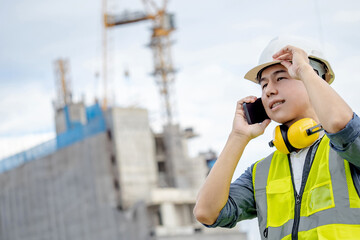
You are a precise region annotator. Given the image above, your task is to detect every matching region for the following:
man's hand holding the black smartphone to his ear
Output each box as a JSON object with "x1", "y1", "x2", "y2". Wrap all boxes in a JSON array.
[{"x1": 232, "y1": 96, "x2": 271, "y2": 140}]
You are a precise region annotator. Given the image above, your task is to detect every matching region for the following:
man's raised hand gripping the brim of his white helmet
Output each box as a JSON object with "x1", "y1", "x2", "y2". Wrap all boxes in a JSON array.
[{"x1": 273, "y1": 45, "x2": 315, "y2": 80}]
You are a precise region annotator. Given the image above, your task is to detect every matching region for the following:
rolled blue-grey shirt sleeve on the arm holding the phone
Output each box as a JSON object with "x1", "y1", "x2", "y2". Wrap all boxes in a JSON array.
[{"x1": 204, "y1": 164, "x2": 256, "y2": 228}]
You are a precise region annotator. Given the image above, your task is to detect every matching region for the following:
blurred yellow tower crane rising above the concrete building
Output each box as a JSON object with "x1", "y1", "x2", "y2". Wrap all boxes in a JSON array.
[{"x1": 103, "y1": 0, "x2": 175, "y2": 124}]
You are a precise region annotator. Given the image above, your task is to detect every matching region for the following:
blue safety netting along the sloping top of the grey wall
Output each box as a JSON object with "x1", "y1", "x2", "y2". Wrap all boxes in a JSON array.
[{"x1": 0, "y1": 104, "x2": 106, "y2": 173}]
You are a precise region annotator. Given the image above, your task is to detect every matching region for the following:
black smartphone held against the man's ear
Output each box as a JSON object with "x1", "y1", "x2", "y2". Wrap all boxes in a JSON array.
[{"x1": 243, "y1": 98, "x2": 269, "y2": 124}]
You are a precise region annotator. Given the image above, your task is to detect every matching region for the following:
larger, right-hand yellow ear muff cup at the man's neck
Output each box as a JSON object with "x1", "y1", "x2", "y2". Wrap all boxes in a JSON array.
[{"x1": 287, "y1": 118, "x2": 319, "y2": 149}]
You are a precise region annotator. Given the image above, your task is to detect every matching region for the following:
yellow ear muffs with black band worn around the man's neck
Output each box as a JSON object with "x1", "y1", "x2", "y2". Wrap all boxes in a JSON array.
[{"x1": 269, "y1": 118, "x2": 322, "y2": 154}]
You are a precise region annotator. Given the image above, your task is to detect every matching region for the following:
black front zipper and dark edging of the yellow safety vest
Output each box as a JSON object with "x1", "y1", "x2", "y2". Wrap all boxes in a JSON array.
[{"x1": 288, "y1": 145, "x2": 314, "y2": 240}]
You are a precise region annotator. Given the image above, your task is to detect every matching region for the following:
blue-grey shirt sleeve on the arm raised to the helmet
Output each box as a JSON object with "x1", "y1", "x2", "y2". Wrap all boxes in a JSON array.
[{"x1": 326, "y1": 113, "x2": 360, "y2": 167}]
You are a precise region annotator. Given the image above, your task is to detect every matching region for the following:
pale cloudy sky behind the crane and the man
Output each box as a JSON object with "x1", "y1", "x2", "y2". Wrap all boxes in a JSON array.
[{"x1": 0, "y1": 0, "x2": 360, "y2": 238}]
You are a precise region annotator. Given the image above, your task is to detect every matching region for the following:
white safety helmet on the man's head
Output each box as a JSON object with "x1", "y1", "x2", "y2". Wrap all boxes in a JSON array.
[{"x1": 245, "y1": 36, "x2": 335, "y2": 84}]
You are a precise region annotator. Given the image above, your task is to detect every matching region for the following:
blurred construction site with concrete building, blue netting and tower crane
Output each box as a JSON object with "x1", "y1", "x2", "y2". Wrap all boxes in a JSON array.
[{"x1": 0, "y1": 0, "x2": 247, "y2": 240}]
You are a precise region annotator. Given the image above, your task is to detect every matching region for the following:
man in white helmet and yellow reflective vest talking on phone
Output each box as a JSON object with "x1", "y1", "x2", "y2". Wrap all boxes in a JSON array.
[{"x1": 194, "y1": 38, "x2": 360, "y2": 240}]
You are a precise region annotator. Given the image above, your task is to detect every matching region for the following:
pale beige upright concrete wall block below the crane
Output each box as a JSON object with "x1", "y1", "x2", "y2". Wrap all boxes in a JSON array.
[{"x1": 110, "y1": 108, "x2": 158, "y2": 208}]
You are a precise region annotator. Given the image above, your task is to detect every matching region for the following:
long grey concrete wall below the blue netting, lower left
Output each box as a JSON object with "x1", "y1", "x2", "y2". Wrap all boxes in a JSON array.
[{"x1": 0, "y1": 133, "x2": 149, "y2": 240}]
